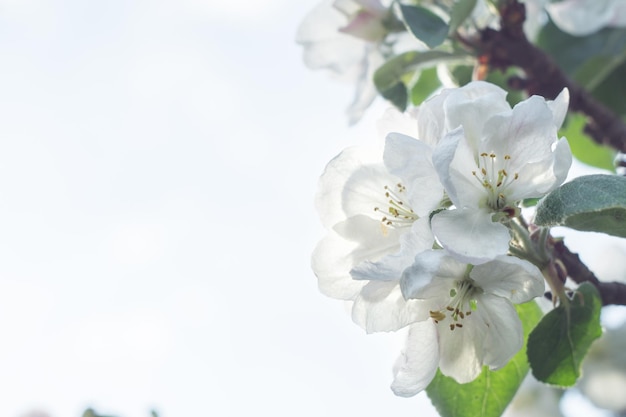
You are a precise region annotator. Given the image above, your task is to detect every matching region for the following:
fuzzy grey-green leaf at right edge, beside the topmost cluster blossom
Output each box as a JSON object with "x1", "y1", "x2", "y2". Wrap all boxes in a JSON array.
[{"x1": 535, "y1": 174, "x2": 626, "y2": 237}]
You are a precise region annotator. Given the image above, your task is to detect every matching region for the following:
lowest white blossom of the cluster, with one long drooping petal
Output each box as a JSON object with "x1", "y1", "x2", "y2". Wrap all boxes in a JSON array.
[{"x1": 392, "y1": 250, "x2": 544, "y2": 396}]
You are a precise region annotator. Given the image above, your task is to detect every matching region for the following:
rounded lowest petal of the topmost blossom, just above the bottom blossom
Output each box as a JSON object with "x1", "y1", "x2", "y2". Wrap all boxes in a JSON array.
[{"x1": 431, "y1": 209, "x2": 511, "y2": 265}]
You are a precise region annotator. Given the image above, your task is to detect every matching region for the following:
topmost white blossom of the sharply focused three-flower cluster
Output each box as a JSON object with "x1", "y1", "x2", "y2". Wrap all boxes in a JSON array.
[{"x1": 431, "y1": 81, "x2": 572, "y2": 264}]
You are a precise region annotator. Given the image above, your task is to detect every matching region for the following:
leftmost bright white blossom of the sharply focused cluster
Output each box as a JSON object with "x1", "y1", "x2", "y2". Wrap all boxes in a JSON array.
[{"x1": 312, "y1": 109, "x2": 443, "y2": 332}]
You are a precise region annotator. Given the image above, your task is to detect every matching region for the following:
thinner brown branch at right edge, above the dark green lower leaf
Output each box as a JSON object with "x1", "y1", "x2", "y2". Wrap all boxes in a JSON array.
[{"x1": 554, "y1": 240, "x2": 626, "y2": 305}]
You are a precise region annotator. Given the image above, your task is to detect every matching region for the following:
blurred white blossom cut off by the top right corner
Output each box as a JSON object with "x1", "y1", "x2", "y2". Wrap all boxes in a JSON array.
[{"x1": 545, "y1": 0, "x2": 626, "y2": 36}]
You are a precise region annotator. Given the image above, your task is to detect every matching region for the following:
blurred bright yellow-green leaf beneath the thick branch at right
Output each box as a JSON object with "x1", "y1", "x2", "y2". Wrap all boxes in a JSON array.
[{"x1": 559, "y1": 114, "x2": 616, "y2": 172}]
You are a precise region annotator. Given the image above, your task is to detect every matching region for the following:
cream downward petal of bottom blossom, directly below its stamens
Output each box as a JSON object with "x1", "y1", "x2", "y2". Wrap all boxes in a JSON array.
[{"x1": 436, "y1": 314, "x2": 487, "y2": 384}]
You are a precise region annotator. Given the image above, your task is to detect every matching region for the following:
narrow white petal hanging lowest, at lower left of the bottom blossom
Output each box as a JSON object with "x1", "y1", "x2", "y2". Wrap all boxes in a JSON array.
[{"x1": 391, "y1": 320, "x2": 439, "y2": 397}]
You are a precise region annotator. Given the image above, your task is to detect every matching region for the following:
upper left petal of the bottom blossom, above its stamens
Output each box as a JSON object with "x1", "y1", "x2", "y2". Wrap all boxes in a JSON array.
[{"x1": 400, "y1": 250, "x2": 466, "y2": 299}]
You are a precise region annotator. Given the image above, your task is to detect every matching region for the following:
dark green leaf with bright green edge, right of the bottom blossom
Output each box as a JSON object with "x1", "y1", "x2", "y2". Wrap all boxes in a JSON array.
[{"x1": 528, "y1": 283, "x2": 602, "y2": 387}]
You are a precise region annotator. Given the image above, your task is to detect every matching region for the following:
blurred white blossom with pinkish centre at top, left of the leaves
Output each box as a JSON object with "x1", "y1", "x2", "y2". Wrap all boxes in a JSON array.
[{"x1": 296, "y1": 0, "x2": 393, "y2": 124}]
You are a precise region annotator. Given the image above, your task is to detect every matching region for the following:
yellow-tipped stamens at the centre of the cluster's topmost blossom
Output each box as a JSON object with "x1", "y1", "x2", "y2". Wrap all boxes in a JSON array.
[{"x1": 472, "y1": 152, "x2": 519, "y2": 210}]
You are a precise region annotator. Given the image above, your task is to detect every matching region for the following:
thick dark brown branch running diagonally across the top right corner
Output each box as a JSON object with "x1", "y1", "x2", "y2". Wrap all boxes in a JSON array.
[{"x1": 476, "y1": 0, "x2": 626, "y2": 152}]
